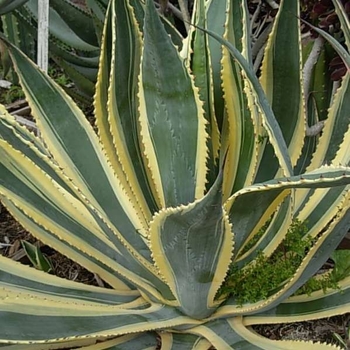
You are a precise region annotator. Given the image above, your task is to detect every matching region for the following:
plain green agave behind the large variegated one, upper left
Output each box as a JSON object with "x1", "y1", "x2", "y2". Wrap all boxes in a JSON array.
[{"x1": 9, "y1": 0, "x2": 182, "y2": 103}]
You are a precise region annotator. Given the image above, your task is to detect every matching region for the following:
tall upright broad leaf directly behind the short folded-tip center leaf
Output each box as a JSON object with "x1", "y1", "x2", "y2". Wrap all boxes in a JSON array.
[{"x1": 139, "y1": 0, "x2": 207, "y2": 208}]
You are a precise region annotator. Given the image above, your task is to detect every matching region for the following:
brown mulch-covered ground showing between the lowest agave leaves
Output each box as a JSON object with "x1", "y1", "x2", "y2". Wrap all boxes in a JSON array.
[{"x1": 0, "y1": 205, "x2": 350, "y2": 350}]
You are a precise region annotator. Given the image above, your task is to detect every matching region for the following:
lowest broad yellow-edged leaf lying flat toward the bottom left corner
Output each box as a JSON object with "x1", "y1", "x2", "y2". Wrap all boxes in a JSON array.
[{"x1": 0, "y1": 294, "x2": 198, "y2": 342}]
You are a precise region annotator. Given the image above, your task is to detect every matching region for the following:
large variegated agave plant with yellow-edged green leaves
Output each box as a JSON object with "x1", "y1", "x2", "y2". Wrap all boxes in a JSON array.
[{"x1": 0, "y1": 0, "x2": 350, "y2": 350}]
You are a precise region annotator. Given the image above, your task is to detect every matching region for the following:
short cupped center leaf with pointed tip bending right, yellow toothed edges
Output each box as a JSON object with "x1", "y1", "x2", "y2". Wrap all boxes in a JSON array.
[{"x1": 150, "y1": 174, "x2": 232, "y2": 319}]
